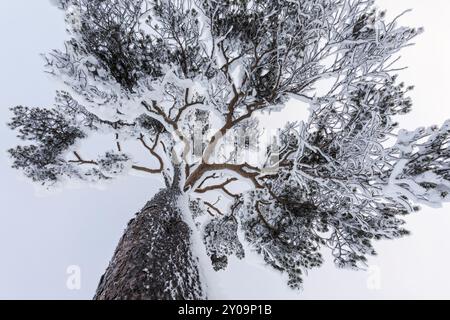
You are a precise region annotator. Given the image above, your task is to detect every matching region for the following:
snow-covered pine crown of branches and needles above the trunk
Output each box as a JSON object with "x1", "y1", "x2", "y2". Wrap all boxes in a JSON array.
[{"x1": 10, "y1": 0, "x2": 450, "y2": 288}]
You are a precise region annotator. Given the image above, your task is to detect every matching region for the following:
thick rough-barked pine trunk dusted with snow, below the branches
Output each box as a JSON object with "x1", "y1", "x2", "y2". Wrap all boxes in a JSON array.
[{"x1": 94, "y1": 168, "x2": 205, "y2": 300}]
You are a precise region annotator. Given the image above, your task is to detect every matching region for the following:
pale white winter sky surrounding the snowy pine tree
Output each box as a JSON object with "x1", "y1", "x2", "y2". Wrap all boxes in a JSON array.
[{"x1": 0, "y1": 0, "x2": 450, "y2": 299}]
